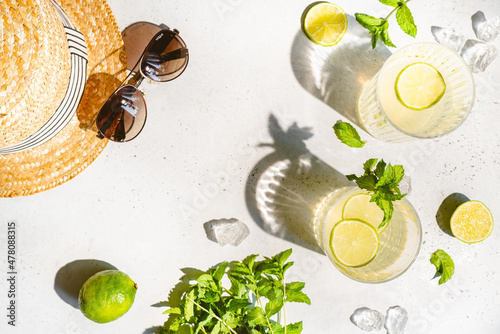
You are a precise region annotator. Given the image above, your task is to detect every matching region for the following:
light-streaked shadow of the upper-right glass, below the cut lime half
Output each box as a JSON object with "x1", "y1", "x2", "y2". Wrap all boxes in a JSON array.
[{"x1": 291, "y1": 15, "x2": 391, "y2": 127}]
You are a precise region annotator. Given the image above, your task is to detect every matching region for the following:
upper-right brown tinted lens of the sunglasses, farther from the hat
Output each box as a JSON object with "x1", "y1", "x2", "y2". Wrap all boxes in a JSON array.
[{"x1": 141, "y1": 30, "x2": 189, "y2": 81}]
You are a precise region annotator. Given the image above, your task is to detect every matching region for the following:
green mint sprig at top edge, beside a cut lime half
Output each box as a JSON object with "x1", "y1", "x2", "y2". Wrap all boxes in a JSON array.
[{"x1": 354, "y1": 0, "x2": 417, "y2": 49}]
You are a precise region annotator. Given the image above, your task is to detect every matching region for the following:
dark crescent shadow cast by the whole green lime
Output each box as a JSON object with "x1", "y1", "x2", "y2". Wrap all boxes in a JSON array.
[{"x1": 54, "y1": 259, "x2": 117, "y2": 308}]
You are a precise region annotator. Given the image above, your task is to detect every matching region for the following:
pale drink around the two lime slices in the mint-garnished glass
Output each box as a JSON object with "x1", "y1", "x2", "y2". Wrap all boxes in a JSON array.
[{"x1": 313, "y1": 187, "x2": 422, "y2": 283}]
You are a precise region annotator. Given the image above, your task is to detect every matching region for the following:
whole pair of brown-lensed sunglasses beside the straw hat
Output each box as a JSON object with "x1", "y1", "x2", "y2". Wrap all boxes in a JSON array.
[{"x1": 96, "y1": 29, "x2": 189, "y2": 142}]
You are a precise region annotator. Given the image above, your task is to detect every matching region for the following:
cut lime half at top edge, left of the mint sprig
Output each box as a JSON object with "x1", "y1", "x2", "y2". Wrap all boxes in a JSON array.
[{"x1": 302, "y1": 2, "x2": 347, "y2": 46}]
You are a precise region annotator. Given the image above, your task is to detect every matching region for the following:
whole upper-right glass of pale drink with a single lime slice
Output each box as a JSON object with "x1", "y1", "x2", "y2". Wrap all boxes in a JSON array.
[{"x1": 358, "y1": 43, "x2": 475, "y2": 142}]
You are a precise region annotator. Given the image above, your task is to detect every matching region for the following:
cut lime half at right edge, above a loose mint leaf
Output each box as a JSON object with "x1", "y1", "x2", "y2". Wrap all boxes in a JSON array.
[{"x1": 450, "y1": 201, "x2": 493, "y2": 244}]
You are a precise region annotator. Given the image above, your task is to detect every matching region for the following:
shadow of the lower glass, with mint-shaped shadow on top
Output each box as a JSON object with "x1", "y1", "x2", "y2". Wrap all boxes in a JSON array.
[{"x1": 245, "y1": 115, "x2": 350, "y2": 254}]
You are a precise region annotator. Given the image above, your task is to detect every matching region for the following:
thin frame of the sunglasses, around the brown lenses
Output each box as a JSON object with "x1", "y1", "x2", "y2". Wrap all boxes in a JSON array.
[{"x1": 96, "y1": 24, "x2": 189, "y2": 143}]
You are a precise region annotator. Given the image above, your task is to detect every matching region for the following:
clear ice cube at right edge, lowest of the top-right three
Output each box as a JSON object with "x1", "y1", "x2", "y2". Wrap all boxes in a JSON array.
[{"x1": 461, "y1": 39, "x2": 498, "y2": 73}]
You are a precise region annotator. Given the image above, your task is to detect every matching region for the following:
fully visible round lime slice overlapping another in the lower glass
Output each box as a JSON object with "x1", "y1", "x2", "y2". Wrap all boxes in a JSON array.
[{"x1": 330, "y1": 219, "x2": 379, "y2": 267}]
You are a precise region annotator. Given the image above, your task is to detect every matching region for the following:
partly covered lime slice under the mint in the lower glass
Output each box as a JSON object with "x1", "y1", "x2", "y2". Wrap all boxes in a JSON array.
[{"x1": 342, "y1": 194, "x2": 389, "y2": 234}]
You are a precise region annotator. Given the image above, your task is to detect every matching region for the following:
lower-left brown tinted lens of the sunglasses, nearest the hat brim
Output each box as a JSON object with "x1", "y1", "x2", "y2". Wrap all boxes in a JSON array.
[{"x1": 96, "y1": 85, "x2": 146, "y2": 142}]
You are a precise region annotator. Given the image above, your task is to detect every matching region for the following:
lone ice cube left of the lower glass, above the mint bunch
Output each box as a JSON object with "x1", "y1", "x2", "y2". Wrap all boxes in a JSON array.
[{"x1": 203, "y1": 218, "x2": 250, "y2": 246}]
